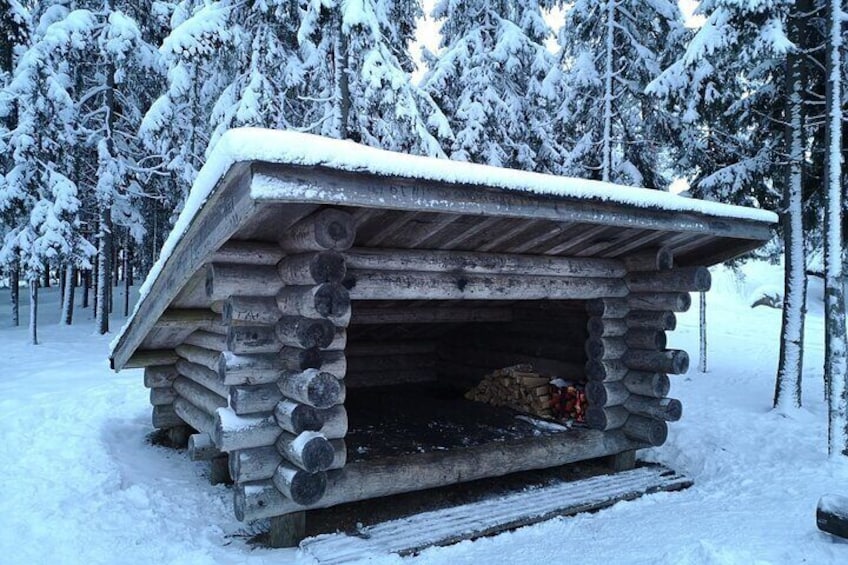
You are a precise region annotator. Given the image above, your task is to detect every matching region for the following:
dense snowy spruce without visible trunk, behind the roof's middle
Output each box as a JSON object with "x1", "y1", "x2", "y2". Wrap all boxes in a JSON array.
[{"x1": 422, "y1": 0, "x2": 561, "y2": 172}]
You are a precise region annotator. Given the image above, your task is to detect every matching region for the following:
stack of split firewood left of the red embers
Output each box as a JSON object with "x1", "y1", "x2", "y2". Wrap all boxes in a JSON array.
[{"x1": 465, "y1": 364, "x2": 553, "y2": 418}]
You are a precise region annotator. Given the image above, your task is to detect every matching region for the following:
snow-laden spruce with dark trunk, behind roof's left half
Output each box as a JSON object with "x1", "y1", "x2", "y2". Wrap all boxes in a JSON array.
[{"x1": 298, "y1": 0, "x2": 451, "y2": 156}]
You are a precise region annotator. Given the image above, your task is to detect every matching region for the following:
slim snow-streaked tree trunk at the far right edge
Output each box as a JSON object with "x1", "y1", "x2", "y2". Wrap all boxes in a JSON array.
[{"x1": 824, "y1": 0, "x2": 848, "y2": 457}]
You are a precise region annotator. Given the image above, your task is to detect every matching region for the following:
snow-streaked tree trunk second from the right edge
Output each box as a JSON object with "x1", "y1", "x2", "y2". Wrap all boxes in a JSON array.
[{"x1": 774, "y1": 5, "x2": 811, "y2": 411}]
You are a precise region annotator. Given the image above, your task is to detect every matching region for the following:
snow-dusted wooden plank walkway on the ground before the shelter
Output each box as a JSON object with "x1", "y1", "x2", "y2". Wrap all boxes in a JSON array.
[{"x1": 300, "y1": 466, "x2": 692, "y2": 565}]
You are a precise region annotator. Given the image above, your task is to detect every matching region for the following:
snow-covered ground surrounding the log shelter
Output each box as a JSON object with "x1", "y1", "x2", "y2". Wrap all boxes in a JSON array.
[{"x1": 0, "y1": 264, "x2": 848, "y2": 565}]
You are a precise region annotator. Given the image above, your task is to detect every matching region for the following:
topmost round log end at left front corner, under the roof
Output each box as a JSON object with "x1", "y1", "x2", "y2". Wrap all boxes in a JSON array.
[{"x1": 280, "y1": 208, "x2": 356, "y2": 253}]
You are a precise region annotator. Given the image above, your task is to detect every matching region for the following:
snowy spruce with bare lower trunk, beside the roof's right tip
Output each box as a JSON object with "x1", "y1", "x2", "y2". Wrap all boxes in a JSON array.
[{"x1": 648, "y1": 0, "x2": 815, "y2": 410}]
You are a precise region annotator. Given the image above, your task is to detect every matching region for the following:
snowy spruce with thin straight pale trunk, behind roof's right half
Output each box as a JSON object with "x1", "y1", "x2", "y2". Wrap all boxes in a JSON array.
[{"x1": 557, "y1": 0, "x2": 688, "y2": 190}]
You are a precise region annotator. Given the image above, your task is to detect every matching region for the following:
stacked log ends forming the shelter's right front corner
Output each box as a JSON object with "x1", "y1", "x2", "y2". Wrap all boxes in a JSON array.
[{"x1": 586, "y1": 248, "x2": 696, "y2": 446}]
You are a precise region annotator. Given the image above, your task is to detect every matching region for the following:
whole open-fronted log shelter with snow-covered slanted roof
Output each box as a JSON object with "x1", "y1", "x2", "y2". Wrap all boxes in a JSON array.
[{"x1": 111, "y1": 129, "x2": 776, "y2": 541}]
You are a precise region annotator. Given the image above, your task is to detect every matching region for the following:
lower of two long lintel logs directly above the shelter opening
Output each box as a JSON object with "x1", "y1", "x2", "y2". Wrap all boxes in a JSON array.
[{"x1": 345, "y1": 269, "x2": 627, "y2": 300}]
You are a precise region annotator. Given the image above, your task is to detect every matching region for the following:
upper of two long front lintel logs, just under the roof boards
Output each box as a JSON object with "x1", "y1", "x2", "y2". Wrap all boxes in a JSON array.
[{"x1": 345, "y1": 248, "x2": 626, "y2": 279}]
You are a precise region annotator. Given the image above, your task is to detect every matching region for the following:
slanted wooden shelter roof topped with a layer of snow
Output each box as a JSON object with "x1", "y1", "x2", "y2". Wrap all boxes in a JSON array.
[{"x1": 111, "y1": 129, "x2": 777, "y2": 370}]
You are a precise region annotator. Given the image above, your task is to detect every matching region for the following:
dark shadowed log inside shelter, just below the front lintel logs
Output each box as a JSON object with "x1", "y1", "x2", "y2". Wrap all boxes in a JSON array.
[{"x1": 350, "y1": 305, "x2": 512, "y2": 325}]
